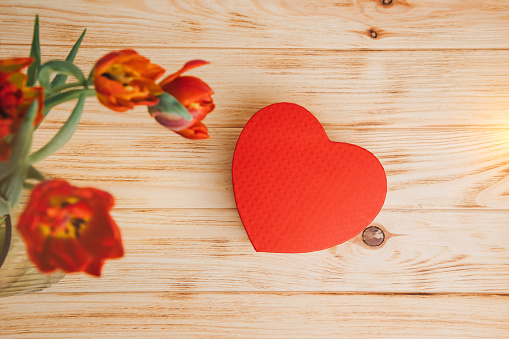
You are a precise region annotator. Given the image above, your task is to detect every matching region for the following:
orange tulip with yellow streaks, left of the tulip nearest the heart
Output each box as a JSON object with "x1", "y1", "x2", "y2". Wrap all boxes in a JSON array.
[{"x1": 93, "y1": 49, "x2": 164, "y2": 112}]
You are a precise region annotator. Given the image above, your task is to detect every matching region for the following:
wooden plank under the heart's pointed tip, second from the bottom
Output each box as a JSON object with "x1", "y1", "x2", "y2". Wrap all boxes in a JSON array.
[{"x1": 5, "y1": 209, "x2": 496, "y2": 293}]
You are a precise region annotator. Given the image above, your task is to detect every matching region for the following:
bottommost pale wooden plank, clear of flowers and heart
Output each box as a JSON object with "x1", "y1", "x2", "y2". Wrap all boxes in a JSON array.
[{"x1": 0, "y1": 293, "x2": 509, "y2": 338}]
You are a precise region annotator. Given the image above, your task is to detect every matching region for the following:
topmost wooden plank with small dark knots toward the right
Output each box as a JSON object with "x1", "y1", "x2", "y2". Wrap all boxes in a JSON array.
[{"x1": 0, "y1": 0, "x2": 509, "y2": 50}]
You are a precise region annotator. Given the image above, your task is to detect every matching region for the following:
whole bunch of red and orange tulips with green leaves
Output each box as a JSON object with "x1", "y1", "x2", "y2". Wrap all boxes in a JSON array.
[{"x1": 0, "y1": 17, "x2": 214, "y2": 276}]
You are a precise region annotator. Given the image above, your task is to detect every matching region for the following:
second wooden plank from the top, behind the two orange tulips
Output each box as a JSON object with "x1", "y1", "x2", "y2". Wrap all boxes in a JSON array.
[{"x1": 0, "y1": 46, "x2": 509, "y2": 128}]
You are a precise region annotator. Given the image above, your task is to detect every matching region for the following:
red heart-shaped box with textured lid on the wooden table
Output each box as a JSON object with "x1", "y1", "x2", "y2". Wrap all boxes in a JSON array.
[{"x1": 232, "y1": 103, "x2": 387, "y2": 253}]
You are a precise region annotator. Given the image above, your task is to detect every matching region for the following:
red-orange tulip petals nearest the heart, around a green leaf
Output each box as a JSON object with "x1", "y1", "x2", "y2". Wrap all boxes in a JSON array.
[{"x1": 150, "y1": 60, "x2": 215, "y2": 139}]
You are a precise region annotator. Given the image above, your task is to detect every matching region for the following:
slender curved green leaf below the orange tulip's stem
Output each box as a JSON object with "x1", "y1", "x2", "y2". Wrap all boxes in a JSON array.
[{"x1": 30, "y1": 94, "x2": 87, "y2": 164}]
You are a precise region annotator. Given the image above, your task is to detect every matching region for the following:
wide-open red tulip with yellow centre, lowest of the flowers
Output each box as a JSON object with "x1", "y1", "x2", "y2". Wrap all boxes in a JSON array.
[{"x1": 17, "y1": 180, "x2": 124, "y2": 276}]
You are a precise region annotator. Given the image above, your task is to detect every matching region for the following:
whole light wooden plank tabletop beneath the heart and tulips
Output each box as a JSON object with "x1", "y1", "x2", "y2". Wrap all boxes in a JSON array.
[{"x1": 0, "y1": 0, "x2": 509, "y2": 338}]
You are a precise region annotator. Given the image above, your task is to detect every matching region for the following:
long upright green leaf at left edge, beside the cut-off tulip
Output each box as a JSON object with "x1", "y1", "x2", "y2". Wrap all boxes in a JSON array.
[{"x1": 0, "y1": 101, "x2": 38, "y2": 208}]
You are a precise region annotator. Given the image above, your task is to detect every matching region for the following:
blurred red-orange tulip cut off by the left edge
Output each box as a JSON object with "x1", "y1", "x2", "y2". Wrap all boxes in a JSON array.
[{"x1": 0, "y1": 58, "x2": 44, "y2": 161}]
